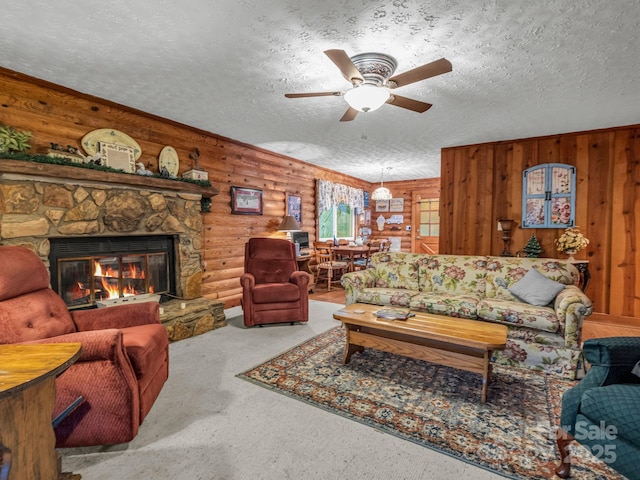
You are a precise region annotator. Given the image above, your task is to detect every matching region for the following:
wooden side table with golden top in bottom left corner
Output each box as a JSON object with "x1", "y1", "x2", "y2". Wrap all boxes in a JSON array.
[{"x1": 0, "y1": 343, "x2": 81, "y2": 480}]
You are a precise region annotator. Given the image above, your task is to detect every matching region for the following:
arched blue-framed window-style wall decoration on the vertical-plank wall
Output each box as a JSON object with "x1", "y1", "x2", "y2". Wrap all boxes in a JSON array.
[{"x1": 522, "y1": 163, "x2": 576, "y2": 228}]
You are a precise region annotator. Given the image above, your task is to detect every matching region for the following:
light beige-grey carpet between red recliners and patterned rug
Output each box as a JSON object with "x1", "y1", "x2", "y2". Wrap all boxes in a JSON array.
[{"x1": 62, "y1": 300, "x2": 503, "y2": 480}]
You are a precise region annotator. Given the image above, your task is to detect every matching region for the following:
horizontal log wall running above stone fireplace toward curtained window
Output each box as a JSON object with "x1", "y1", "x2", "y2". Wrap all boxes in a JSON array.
[{"x1": 0, "y1": 68, "x2": 380, "y2": 307}]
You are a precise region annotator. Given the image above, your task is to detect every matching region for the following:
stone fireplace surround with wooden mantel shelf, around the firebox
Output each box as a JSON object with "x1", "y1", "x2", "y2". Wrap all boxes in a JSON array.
[{"x1": 0, "y1": 159, "x2": 218, "y2": 299}]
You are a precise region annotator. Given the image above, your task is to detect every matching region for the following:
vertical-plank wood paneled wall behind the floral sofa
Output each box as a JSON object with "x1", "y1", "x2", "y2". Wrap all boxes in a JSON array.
[{"x1": 440, "y1": 125, "x2": 640, "y2": 317}]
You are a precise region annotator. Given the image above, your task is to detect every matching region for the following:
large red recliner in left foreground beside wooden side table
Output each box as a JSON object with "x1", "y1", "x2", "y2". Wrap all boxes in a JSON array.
[{"x1": 0, "y1": 246, "x2": 169, "y2": 447}]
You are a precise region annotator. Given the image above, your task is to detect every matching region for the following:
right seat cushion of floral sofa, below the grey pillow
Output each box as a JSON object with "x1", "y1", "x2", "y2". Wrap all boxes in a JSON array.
[{"x1": 478, "y1": 298, "x2": 560, "y2": 333}]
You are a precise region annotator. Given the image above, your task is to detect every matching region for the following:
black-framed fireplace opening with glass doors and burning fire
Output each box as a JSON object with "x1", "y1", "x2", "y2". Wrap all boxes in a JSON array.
[{"x1": 49, "y1": 235, "x2": 177, "y2": 309}]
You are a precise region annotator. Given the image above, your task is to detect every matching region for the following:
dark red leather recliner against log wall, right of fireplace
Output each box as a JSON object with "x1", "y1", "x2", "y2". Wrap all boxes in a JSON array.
[{"x1": 240, "y1": 238, "x2": 309, "y2": 327}]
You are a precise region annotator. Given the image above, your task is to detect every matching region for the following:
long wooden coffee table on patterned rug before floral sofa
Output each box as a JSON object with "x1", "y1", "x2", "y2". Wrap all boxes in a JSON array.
[{"x1": 333, "y1": 303, "x2": 507, "y2": 403}]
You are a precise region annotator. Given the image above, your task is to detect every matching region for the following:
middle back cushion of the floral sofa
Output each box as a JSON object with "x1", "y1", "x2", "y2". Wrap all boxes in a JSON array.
[{"x1": 418, "y1": 255, "x2": 486, "y2": 296}]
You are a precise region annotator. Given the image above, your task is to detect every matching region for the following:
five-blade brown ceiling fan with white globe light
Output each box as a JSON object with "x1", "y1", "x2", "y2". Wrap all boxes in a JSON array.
[{"x1": 284, "y1": 50, "x2": 452, "y2": 122}]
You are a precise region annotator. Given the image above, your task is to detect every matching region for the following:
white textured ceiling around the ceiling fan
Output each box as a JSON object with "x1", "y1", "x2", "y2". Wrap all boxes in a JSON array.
[{"x1": 0, "y1": 0, "x2": 640, "y2": 182}]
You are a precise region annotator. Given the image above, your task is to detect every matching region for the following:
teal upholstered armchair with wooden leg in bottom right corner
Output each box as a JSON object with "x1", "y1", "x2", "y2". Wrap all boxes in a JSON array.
[{"x1": 556, "y1": 337, "x2": 640, "y2": 480}]
